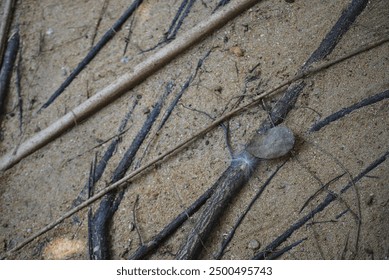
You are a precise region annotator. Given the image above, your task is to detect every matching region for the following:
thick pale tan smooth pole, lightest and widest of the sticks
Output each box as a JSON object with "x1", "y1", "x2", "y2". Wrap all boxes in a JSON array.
[{"x1": 0, "y1": 0, "x2": 264, "y2": 170}]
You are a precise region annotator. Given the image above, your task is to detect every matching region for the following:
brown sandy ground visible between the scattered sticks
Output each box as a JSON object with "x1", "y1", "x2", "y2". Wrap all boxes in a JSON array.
[{"x1": 0, "y1": 0, "x2": 389, "y2": 259}]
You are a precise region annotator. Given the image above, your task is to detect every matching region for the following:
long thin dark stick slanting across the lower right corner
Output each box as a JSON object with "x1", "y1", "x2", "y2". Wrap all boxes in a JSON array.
[{"x1": 254, "y1": 152, "x2": 389, "y2": 260}]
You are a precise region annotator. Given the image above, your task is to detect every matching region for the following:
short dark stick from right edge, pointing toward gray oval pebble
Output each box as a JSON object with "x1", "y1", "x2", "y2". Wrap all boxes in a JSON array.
[{"x1": 309, "y1": 90, "x2": 389, "y2": 132}]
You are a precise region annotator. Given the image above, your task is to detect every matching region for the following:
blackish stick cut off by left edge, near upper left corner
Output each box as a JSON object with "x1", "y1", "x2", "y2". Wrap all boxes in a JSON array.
[{"x1": 0, "y1": 29, "x2": 19, "y2": 115}]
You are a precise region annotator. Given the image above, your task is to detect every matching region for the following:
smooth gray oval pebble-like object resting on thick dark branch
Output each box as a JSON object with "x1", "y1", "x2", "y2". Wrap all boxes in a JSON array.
[{"x1": 246, "y1": 126, "x2": 295, "y2": 159}]
